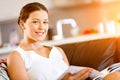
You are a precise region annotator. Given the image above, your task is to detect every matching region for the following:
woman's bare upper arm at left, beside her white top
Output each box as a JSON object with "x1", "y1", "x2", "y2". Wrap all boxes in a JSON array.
[{"x1": 7, "y1": 51, "x2": 29, "y2": 80}]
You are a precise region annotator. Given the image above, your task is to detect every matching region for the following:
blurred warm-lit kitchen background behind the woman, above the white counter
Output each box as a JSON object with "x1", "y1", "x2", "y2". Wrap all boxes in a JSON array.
[{"x1": 0, "y1": 0, "x2": 120, "y2": 57}]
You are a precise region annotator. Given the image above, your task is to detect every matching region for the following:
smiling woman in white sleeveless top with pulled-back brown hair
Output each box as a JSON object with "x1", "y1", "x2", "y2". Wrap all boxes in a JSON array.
[{"x1": 7, "y1": 2, "x2": 91, "y2": 80}]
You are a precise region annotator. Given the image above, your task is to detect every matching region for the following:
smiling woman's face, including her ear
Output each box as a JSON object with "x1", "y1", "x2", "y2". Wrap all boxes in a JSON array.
[{"x1": 22, "y1": 10, "x2": 49, "y2": 41}]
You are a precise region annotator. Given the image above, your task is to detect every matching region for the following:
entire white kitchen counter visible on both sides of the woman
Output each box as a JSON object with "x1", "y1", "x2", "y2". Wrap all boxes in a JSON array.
[{"x1": 0, "y1": 34, "x2": 120, "y2": 55}]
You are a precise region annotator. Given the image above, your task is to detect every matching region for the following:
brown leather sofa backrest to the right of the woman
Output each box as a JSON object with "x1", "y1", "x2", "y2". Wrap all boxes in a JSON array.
[{"x1": 57, "y1": 37, "x2": 120, "y2": 70}]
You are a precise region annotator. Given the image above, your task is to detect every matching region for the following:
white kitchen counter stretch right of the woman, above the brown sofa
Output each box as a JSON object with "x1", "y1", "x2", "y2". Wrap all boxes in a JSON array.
[{"x1": 41, "y1": 33, "x2": 120, "y2": 46}]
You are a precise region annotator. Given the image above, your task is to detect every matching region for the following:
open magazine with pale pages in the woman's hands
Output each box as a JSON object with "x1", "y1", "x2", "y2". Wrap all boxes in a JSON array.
[{"x1": 59, "y1": 63, "x2": 120, "y2": 80}]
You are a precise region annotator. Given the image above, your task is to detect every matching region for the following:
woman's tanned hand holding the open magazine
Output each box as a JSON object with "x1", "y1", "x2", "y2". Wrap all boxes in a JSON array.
[{"x1": 62, "y1": 68, "x2": 92, "y2": 80}]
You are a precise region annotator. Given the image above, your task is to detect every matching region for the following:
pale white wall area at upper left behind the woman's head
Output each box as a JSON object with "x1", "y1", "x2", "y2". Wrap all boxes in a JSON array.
[{"x1": 0, "y1": 0, "x2": 53, "y2": 22}]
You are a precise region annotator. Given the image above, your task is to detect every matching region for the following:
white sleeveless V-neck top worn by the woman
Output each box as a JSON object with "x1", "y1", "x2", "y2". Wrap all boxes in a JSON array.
[{"x1": 15, "y1": 47, "x2": 68, "y2": 80}]
